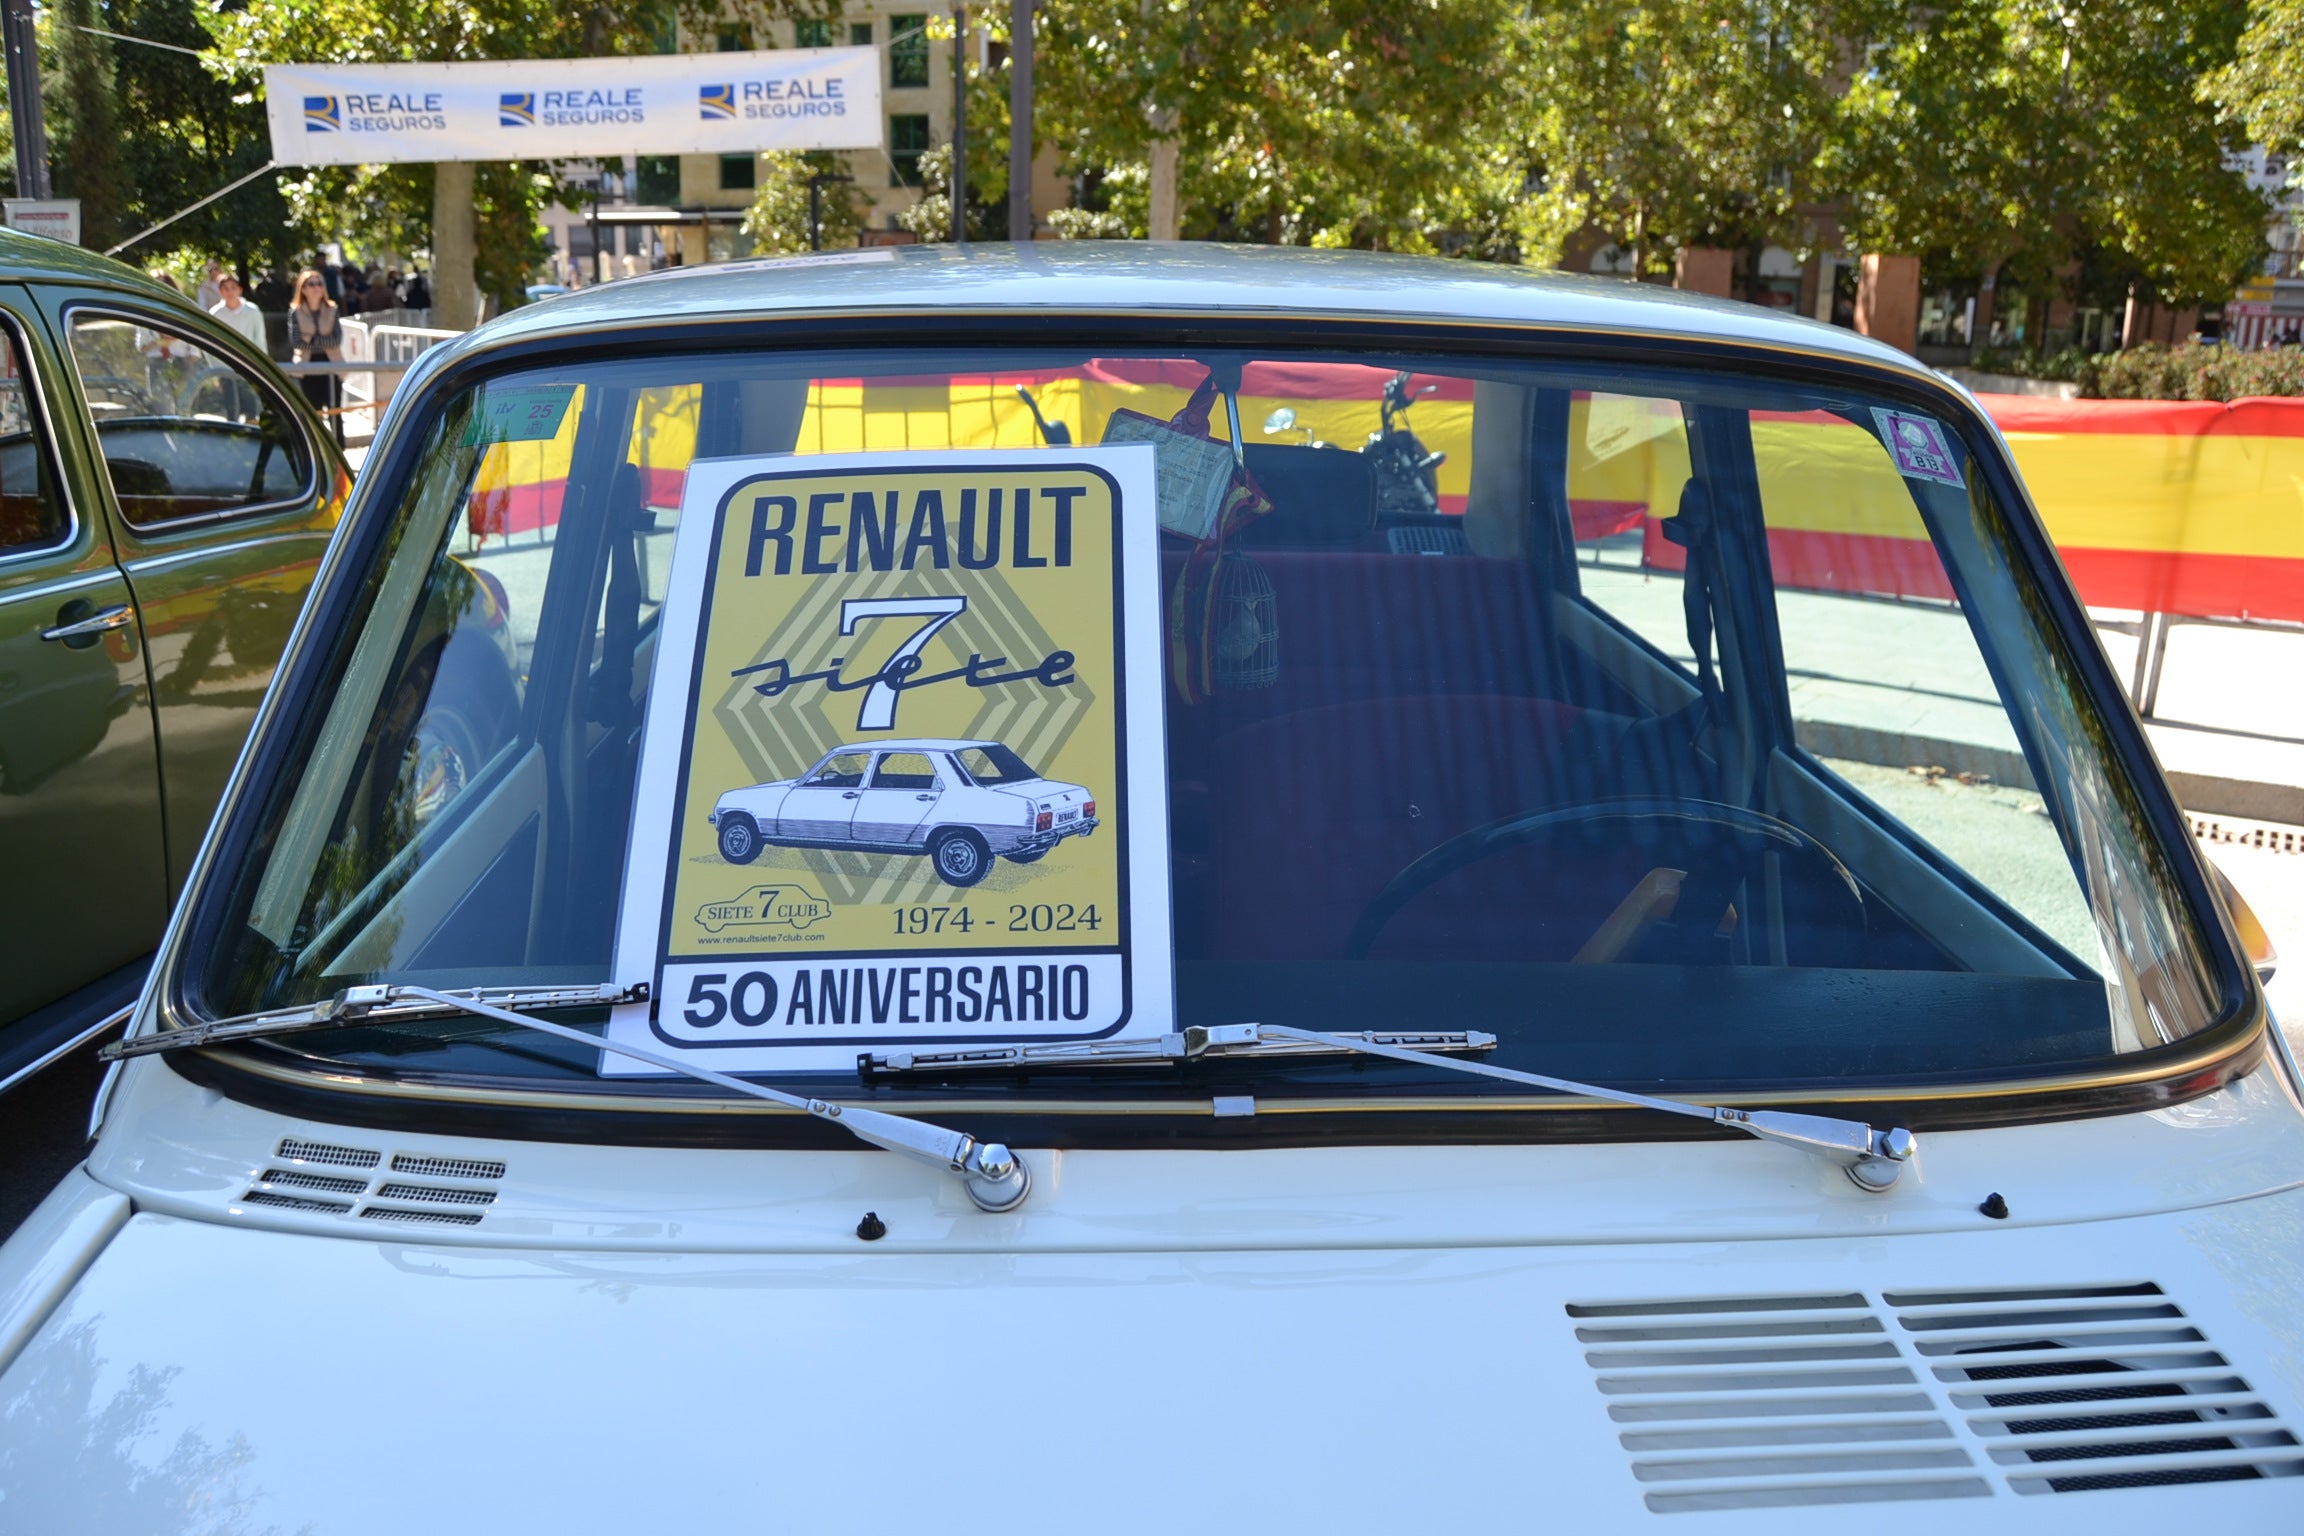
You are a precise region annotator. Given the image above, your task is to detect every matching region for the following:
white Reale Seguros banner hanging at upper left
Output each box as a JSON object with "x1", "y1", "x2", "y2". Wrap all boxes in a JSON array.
[{"x1": 265, "y1": 48, "x2": 880, "y2": 166}]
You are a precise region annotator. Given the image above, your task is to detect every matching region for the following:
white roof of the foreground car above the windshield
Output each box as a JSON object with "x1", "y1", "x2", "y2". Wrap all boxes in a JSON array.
[{"x1": 440, "y1": 239, "x2": 1933, "y2": 378}]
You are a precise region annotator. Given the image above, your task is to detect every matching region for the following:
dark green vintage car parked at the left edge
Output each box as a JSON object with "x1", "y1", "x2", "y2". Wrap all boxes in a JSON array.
[{"x1": 0, "y1": 230, "x2": 350, "y2": 1092}]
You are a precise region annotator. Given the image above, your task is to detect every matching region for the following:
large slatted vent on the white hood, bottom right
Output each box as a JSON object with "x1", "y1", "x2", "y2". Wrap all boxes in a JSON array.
[{"x1": 1567, "y1": 1283, "x2": 2304, "y2": 1513}]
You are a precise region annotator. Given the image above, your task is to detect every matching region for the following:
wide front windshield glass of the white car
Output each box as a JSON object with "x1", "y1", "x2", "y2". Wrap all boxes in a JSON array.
[{"x1": 182, "y1": 343, "x2": 2219, "y2": 1096}]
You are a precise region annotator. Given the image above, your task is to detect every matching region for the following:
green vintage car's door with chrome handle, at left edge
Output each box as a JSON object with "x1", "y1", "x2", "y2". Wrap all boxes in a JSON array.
[{"x1": 0, "y1": 286, "x2": 168, "y2": 1045}]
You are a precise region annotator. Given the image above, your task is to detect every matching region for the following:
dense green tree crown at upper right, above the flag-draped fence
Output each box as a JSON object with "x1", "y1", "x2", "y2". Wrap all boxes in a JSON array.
[{"x1": 1820, "y1": 0, "x2": 2267, "y2": 304}]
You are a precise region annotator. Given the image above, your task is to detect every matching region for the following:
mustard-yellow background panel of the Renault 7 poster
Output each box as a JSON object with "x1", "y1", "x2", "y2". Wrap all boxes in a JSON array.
[{"x1": 664, "y1": 463, "x2": 1128, "y2": 960}]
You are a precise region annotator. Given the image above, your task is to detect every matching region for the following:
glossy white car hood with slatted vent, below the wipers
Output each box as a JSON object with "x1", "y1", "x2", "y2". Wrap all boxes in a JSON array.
[{"x1": 13, "y1": 1154, "x2": 2304, "y2": 1536}]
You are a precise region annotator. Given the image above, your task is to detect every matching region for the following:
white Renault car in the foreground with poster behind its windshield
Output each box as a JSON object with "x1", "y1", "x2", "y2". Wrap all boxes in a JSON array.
[{"x1": 0, "y1": 242, "x2": 2304, "y2": 1536}]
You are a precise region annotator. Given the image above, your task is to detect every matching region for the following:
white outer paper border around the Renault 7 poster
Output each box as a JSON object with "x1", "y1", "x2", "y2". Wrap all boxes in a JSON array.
[{"x1": 599, "y1": 444, "x2": 1175, "y2": 1078}]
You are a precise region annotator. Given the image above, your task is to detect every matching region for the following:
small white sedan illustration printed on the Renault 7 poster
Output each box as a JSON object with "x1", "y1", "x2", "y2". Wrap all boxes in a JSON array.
[{"x1": 705, "y1": 739, "x2": 1097, "y2": 889}]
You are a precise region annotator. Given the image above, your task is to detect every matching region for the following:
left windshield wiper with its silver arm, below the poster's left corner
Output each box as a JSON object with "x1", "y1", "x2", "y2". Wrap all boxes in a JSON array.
[{"x1": 99, "y1": 986, "x2": 1032, "y2": 1211}]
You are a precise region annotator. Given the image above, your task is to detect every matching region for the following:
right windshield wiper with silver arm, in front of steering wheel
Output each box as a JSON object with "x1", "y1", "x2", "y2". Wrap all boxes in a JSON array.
[{"x1": 857, "y1": 1025, "x2": 1919, "y2": 1193}]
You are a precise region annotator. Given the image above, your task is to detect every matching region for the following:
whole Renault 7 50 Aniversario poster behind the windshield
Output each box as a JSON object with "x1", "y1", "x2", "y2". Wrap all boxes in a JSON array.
[{"x1": 601, "y1": 447, "x2": 1168, "y2": 1073}]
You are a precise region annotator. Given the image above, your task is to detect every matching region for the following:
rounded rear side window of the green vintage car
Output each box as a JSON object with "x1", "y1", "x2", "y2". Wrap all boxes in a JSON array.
[{"x1": 71, "y1": 315, "x2": 311, "y2": 527}]
